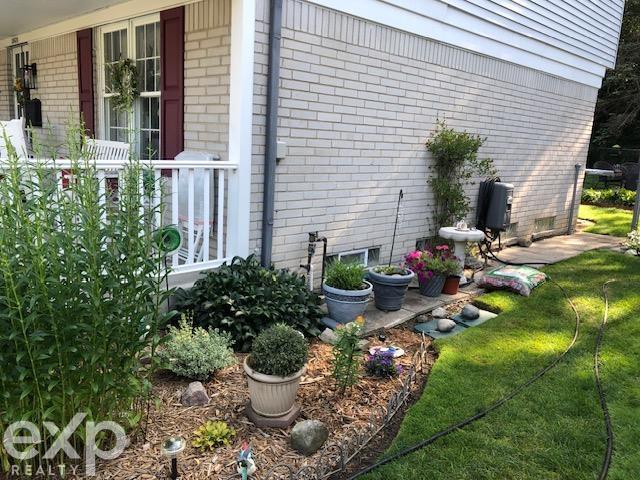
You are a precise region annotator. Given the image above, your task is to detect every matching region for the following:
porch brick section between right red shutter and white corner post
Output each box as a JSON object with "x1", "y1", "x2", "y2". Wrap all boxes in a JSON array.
[{"x1": 184, "y1": 0, "x2": 231, "y2": 160}]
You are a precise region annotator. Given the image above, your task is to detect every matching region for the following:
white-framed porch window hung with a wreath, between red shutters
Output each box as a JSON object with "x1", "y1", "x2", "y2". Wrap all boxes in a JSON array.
[{"x1": 97, "y1": 14, "x2": 161, "y2": 159}]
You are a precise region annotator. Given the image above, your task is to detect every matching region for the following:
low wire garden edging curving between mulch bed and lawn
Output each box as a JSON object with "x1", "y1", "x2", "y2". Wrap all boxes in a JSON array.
[{"x1": 225, "y1": 335, "x2": 427, "y2": 480}]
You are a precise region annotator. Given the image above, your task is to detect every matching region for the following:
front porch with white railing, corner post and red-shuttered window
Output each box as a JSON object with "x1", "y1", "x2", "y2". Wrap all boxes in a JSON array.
[{"x1": 0, "y1": 0, "x2": 256, "y2": 285}]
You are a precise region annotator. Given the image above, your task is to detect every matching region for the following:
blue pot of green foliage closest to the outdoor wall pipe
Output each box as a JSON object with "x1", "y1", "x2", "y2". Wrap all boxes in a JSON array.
[{"x1": 322, "y1": 261, "x2": 373, "y2": 323}]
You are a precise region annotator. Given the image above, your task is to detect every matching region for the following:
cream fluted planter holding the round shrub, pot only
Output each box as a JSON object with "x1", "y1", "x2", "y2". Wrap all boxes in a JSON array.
[{"x1": 244, "y1": 356, "x2": 307, "y2": 417}]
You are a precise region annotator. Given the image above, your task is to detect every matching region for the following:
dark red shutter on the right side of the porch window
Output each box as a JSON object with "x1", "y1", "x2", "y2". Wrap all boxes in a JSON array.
[{"x1": 160, "y1": 7, "x2": 184, "y2": 159}]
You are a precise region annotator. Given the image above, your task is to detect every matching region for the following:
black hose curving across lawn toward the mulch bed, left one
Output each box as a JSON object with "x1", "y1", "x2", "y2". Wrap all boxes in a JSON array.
[{"x1": 348, "y1": 278, "x2": 580, "y2": 480}]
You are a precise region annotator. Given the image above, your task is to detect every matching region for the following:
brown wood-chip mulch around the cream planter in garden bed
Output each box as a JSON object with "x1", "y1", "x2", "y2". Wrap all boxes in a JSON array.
[{"x1": 90, "y1": 327, "x2": 434, "y2": 480}]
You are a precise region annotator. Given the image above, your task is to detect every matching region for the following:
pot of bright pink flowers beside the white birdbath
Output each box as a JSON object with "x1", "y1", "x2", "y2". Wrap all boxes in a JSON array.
[{"x1": 406, "y1": 245, "x2": 458, "y2": 297}]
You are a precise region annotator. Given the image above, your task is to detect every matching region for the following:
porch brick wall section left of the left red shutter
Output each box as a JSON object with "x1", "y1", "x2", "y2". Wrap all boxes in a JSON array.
[{"x1": 30, "y1": 33, "x2": 79, "y2": 154}]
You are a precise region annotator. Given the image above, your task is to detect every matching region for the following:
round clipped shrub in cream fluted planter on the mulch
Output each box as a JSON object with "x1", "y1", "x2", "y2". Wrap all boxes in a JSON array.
[{"x1": 244, "y1": 323, "x2": 309, "y2": 418}]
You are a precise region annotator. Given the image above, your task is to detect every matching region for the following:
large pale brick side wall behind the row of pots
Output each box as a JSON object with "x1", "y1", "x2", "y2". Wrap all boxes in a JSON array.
[{"x1": 252, "y1": 0, "x2": 597, "y2": 274}]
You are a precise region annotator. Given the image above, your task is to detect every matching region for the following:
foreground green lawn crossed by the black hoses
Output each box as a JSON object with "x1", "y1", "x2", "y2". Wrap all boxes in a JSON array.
[{"x1": 364, "y1": 251, "x2": 640, "y2": 480}]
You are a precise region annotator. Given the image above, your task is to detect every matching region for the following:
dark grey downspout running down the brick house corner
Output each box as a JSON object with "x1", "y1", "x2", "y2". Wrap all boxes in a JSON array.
[{"x1": 261, "y1": 0, "x2": 282, "y2": 267}]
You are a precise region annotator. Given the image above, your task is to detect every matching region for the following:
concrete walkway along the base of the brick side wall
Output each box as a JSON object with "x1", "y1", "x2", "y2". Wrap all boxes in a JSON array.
[{"x1": 365, "y1": 232, "x2": 624, "y2": 335}]
